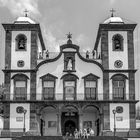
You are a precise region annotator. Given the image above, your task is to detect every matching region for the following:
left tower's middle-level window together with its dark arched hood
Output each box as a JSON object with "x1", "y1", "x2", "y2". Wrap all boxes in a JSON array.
[{"x1": 12, "y1": 74, "x2": 29, "y2": 100}]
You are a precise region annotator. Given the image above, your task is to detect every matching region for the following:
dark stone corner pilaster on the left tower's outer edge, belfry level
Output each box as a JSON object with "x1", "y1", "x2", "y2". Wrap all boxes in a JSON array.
[{"x1": 5, "y1": 30, "x2": 12, "y2": 69}]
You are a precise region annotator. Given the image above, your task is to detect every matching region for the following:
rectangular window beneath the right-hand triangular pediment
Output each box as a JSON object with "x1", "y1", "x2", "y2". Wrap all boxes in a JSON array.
[{"x1": 85, "y1": 81, "x2": 96, "y2": 100}]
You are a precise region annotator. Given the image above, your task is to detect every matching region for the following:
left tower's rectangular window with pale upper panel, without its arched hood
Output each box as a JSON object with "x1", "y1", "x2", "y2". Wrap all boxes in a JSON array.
[{"x1": 15, "y1": 81, "x2": 27, "y2": 100}]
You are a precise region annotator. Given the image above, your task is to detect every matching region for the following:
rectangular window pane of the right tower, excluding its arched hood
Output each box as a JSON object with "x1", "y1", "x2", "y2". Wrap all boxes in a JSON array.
[{"x1": 113, "y1": 81, "x2": 125, "y2": 99}]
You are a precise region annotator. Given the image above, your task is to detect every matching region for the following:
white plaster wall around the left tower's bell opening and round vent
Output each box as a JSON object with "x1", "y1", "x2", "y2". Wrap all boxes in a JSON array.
[{"x1": 11, "y1": 31, "x2": 31, "y2": 69}]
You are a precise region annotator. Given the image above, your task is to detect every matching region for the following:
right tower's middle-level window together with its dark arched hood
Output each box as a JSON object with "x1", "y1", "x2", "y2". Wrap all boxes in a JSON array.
[{"x1": 111, "y1": 74, "x2": 127, "y2": 100}]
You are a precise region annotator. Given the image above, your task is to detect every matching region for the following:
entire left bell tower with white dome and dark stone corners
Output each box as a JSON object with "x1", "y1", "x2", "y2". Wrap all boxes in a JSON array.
[{"x1": 2, "y1": 13, "x2": 45, "y2": 131}]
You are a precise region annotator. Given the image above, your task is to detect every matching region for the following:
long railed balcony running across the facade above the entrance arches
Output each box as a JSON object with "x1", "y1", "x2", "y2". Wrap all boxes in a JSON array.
[{"x1": 0, "y1": 93, "x2": 137, "y2": 102}]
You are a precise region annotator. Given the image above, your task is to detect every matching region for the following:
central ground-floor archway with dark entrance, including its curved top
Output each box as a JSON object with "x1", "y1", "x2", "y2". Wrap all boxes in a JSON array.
[{"x1": 61, "y1": 106, "x2": 79, "y2": 135}]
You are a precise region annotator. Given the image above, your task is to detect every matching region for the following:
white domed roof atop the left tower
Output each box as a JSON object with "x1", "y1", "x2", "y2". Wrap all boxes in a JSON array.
[{"x1": 14, "y1": 16, "x2": 36, "y2": 24}]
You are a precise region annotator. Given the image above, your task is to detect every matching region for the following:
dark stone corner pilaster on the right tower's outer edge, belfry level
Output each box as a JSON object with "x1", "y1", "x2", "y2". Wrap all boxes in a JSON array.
[{"x1": 127, "y1": 31, "x2": 134, "y2": 69}]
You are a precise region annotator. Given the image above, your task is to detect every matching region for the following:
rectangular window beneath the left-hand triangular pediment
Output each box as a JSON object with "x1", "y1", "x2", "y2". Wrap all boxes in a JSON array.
[{"x1": 43, "y1": 81, "x2": 54, "y2": 100}]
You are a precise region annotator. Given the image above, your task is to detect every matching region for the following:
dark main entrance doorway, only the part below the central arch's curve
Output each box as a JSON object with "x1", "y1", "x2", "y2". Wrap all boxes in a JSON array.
[{"x1": 61, "y1": 112, "x2": 79, "y2": 135}]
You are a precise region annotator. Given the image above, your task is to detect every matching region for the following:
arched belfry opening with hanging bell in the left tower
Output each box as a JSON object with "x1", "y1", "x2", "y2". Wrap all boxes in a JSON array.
[{"x1": 16, "y1": 34, "x2": 27, "y2": 51}]
